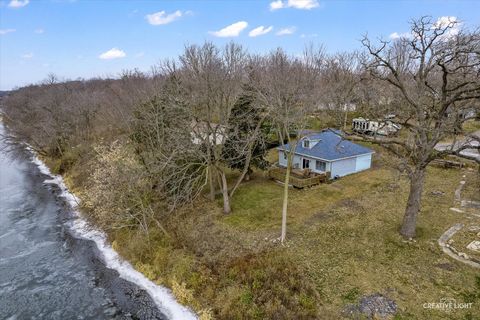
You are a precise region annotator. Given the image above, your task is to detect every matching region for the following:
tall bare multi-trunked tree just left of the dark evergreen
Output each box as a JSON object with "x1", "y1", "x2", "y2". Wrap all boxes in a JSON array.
[{"x1": 145, "y1": 43, "x2": 265, "y2": 214}]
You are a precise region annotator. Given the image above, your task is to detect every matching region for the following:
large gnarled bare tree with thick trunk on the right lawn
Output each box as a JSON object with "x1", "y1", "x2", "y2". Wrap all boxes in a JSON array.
[{"x1": 362, "y1": 17, "x2": 480, "y2": 238}]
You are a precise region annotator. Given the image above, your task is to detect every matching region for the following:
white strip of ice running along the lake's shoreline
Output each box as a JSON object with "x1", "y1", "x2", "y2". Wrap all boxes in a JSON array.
[{"x1": 27, "y1": 147, "x2": 197, "y2": 320}]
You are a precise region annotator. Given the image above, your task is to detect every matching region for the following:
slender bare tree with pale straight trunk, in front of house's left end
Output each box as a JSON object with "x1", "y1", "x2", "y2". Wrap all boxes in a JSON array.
[{"x1": 252, "y1": 49, "x2": 323, "y2": 243}]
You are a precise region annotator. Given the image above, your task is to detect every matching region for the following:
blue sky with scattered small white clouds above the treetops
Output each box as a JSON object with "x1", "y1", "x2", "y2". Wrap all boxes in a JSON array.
[{"x1": 0, "y1": 0, "x2": 480, "y2": 90}]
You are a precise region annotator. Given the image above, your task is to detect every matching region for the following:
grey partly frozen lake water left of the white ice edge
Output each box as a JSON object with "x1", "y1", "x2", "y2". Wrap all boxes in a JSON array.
[{"x1": 0, "y1": 123, "x2": 172, "y2": 319}]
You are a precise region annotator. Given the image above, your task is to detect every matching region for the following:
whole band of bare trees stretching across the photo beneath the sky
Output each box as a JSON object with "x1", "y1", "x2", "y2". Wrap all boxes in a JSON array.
[{"x1": 2, "y1": 17, "x2": 480, "y2": 242}]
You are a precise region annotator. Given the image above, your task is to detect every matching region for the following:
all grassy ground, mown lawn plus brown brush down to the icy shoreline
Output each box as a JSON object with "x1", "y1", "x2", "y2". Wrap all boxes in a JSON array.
[{"x1": 109, "y1": 147, "x2": 480, "y2": 319}]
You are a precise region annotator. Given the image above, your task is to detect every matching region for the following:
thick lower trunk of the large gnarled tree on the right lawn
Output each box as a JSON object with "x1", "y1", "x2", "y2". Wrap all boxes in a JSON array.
[{"x1": 400, "y1": 168, "x2": 425, "y2": 239}]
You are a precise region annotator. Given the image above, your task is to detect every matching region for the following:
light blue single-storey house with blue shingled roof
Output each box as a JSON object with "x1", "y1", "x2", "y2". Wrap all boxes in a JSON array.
[{"x1": 277, "y1": 129, "x2": 374, "y2": 179}]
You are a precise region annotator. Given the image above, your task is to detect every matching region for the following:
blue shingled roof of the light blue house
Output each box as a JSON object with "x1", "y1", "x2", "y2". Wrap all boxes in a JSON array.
[{"x1": 277, "y1": 129, "x2": 374, "y2": 161}]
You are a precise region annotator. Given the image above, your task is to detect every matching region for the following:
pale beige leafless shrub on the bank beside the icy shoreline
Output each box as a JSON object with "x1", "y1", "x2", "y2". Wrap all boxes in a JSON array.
[{"x1": 84, "y1": 141, "x2": 158, "y2": 232}]
